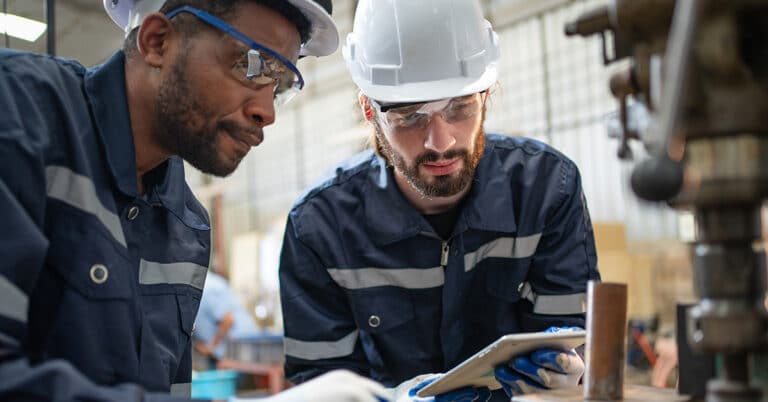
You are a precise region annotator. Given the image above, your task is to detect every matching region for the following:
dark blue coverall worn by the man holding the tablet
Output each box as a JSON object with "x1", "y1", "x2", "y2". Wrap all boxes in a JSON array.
[{"x1": 280, "y1": 134, "x2": 599, "y2": 399}]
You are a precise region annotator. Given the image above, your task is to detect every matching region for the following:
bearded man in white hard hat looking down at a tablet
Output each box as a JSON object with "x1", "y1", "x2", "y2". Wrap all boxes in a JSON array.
[{"x1": 280, "y1": 0, "x2": 599, "y2": 401}]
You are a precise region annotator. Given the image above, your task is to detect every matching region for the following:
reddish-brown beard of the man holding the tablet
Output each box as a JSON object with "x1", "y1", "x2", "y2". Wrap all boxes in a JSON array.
[{"x1": 374, "y1": 111, "x2": 485, "y2": 198}]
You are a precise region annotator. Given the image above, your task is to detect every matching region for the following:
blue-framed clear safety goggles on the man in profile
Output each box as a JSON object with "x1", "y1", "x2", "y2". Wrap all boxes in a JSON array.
[{"x1": 166, "y1": 6, "x2": 304, "y2": 106}]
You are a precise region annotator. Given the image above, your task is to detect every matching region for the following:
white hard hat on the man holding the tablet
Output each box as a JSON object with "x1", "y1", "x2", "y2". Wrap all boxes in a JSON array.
[{"x1": 343, "y1": 0, "x2": 499, "y2": 103}]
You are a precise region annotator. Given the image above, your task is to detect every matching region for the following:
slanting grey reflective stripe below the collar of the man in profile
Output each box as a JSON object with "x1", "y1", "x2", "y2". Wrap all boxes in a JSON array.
[{"x1": 45, "y1": 166, "x2": 126, "y2": 247}]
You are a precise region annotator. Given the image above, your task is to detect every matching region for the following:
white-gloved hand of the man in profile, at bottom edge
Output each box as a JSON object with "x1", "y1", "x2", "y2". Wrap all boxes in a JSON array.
[{"x1": 229, "y1": 370, "x2": 391, "y2": 402}]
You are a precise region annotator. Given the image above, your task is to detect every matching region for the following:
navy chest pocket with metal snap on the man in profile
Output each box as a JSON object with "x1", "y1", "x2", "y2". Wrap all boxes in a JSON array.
[{"x1": 39, "y1": 203, "x2": 138, "y2": 384}]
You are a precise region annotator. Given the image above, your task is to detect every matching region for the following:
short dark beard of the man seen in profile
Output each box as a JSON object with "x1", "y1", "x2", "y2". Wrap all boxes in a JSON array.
[{"x1": 155, "y1": 52, "x2": 240, "y2": 177}]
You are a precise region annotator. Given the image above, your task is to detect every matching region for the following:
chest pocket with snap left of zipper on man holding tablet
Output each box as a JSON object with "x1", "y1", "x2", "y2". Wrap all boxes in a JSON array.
[{"x1": 349, "y1": 287, "x2": 415, "y2": 334}]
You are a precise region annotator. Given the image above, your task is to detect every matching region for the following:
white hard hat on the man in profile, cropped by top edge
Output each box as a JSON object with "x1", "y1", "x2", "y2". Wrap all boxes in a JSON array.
[{"x1": 103, "y1": 0, "x2": 339, "y2": 56}]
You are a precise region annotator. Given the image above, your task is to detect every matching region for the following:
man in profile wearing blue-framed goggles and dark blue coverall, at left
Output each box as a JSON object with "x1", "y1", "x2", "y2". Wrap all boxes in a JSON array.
[{"x1": 0, "y1": 0, "x2": 383, "y2": 402}]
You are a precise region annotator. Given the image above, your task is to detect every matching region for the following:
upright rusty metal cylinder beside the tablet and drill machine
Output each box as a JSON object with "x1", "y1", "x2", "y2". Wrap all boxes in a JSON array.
[{"x1": 584, "y1": 281, "x2": 627, "y2": 401}]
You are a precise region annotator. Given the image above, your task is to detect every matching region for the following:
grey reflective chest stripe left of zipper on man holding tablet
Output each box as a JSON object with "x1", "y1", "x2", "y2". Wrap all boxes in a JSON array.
[{"x1": 328, "y1": 267, "x2": 445, "y2": 289}]
